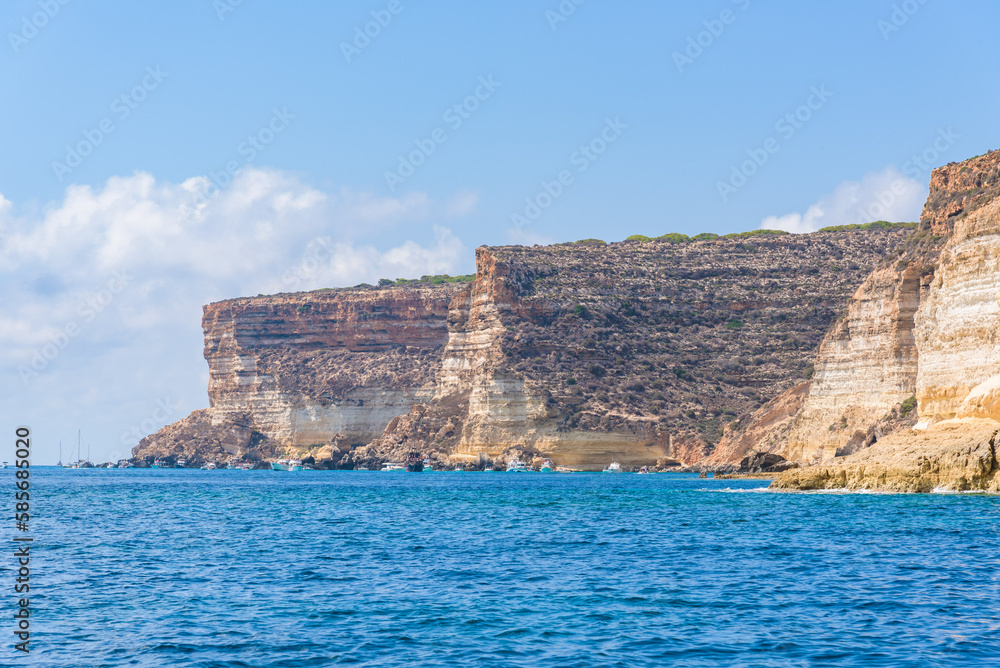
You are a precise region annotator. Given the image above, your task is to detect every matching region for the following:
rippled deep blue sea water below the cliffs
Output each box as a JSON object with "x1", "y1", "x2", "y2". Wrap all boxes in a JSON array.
[{"x1": 7, "y1": 468, "x2": 1000, "y2": 668}]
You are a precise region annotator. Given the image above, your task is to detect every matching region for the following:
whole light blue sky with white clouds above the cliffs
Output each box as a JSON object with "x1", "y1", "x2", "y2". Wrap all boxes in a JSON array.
[{"x1": 0, "y1": 0, "x2": 1000, "y2": 459}]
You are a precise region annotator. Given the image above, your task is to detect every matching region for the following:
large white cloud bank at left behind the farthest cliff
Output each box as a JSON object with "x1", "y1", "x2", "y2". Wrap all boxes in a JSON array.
[{"x1": 0, "y1": 168, "x2": 474, "y2": 463}]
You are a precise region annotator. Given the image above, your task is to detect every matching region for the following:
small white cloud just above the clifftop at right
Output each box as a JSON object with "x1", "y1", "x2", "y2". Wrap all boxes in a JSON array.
[{"x1": 760, "y1": 167, "x2": 927, "y2": 234}]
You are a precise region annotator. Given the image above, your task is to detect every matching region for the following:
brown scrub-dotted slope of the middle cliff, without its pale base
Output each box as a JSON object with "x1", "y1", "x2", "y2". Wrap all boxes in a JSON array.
[{"x1": 480, "y1": 227, "x2": 911, "y2": 453}]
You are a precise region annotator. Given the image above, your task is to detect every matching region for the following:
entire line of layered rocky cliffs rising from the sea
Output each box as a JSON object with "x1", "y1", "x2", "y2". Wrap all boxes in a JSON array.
[{"x1": 133, "y1": 152, "x2": 1000, "y2": 491}]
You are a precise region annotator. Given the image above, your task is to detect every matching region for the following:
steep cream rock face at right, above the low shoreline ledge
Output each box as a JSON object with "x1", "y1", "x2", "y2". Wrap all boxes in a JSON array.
[{"x1": 774, "y1": 151, "x2": 1000, "y2": 462}]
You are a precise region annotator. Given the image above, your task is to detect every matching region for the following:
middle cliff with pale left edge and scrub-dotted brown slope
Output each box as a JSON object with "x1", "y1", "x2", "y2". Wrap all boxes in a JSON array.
[{"x1": 362, "y1": 235, "x2": 909, "y2": 470}]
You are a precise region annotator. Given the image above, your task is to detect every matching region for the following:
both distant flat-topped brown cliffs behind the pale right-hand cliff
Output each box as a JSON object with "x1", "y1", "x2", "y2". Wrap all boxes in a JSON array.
[{"x1": 134, "y1": 227, "x2": 912, "y2": 469}]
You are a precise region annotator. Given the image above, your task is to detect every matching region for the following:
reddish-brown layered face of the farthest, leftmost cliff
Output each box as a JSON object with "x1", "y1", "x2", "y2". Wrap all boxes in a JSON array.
[{"x1": 203, "y1": 285, "x2": 461, "y2": 447}]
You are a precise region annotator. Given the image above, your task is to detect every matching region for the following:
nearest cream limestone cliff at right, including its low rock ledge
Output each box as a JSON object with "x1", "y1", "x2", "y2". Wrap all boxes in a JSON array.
[{"x1": 777, "y1": 151, "x2": 1000, "y2": 491}]
